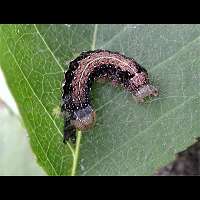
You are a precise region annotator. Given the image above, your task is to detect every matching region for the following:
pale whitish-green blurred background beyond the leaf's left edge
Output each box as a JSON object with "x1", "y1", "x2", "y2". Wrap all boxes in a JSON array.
[{"x1": 0, "y1": 67, "x2": 45, "y2": 176}]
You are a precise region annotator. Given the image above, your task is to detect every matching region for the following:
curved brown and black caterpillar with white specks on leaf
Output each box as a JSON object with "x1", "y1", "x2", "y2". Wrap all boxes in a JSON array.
[{"x1": 61, "y1": 50, "x2": 158, "y2": 143}]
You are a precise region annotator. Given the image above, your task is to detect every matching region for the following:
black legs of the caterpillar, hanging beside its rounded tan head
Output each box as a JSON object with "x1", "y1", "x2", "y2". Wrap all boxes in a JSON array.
[{"x1": 63, "y1": 118, "x2": 76, "y2": 144}]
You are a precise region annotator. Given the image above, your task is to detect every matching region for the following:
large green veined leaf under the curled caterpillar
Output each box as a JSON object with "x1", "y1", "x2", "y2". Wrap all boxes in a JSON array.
[{"x1": 0, "y1": 25, "x2": 200, "y2": 175}]
